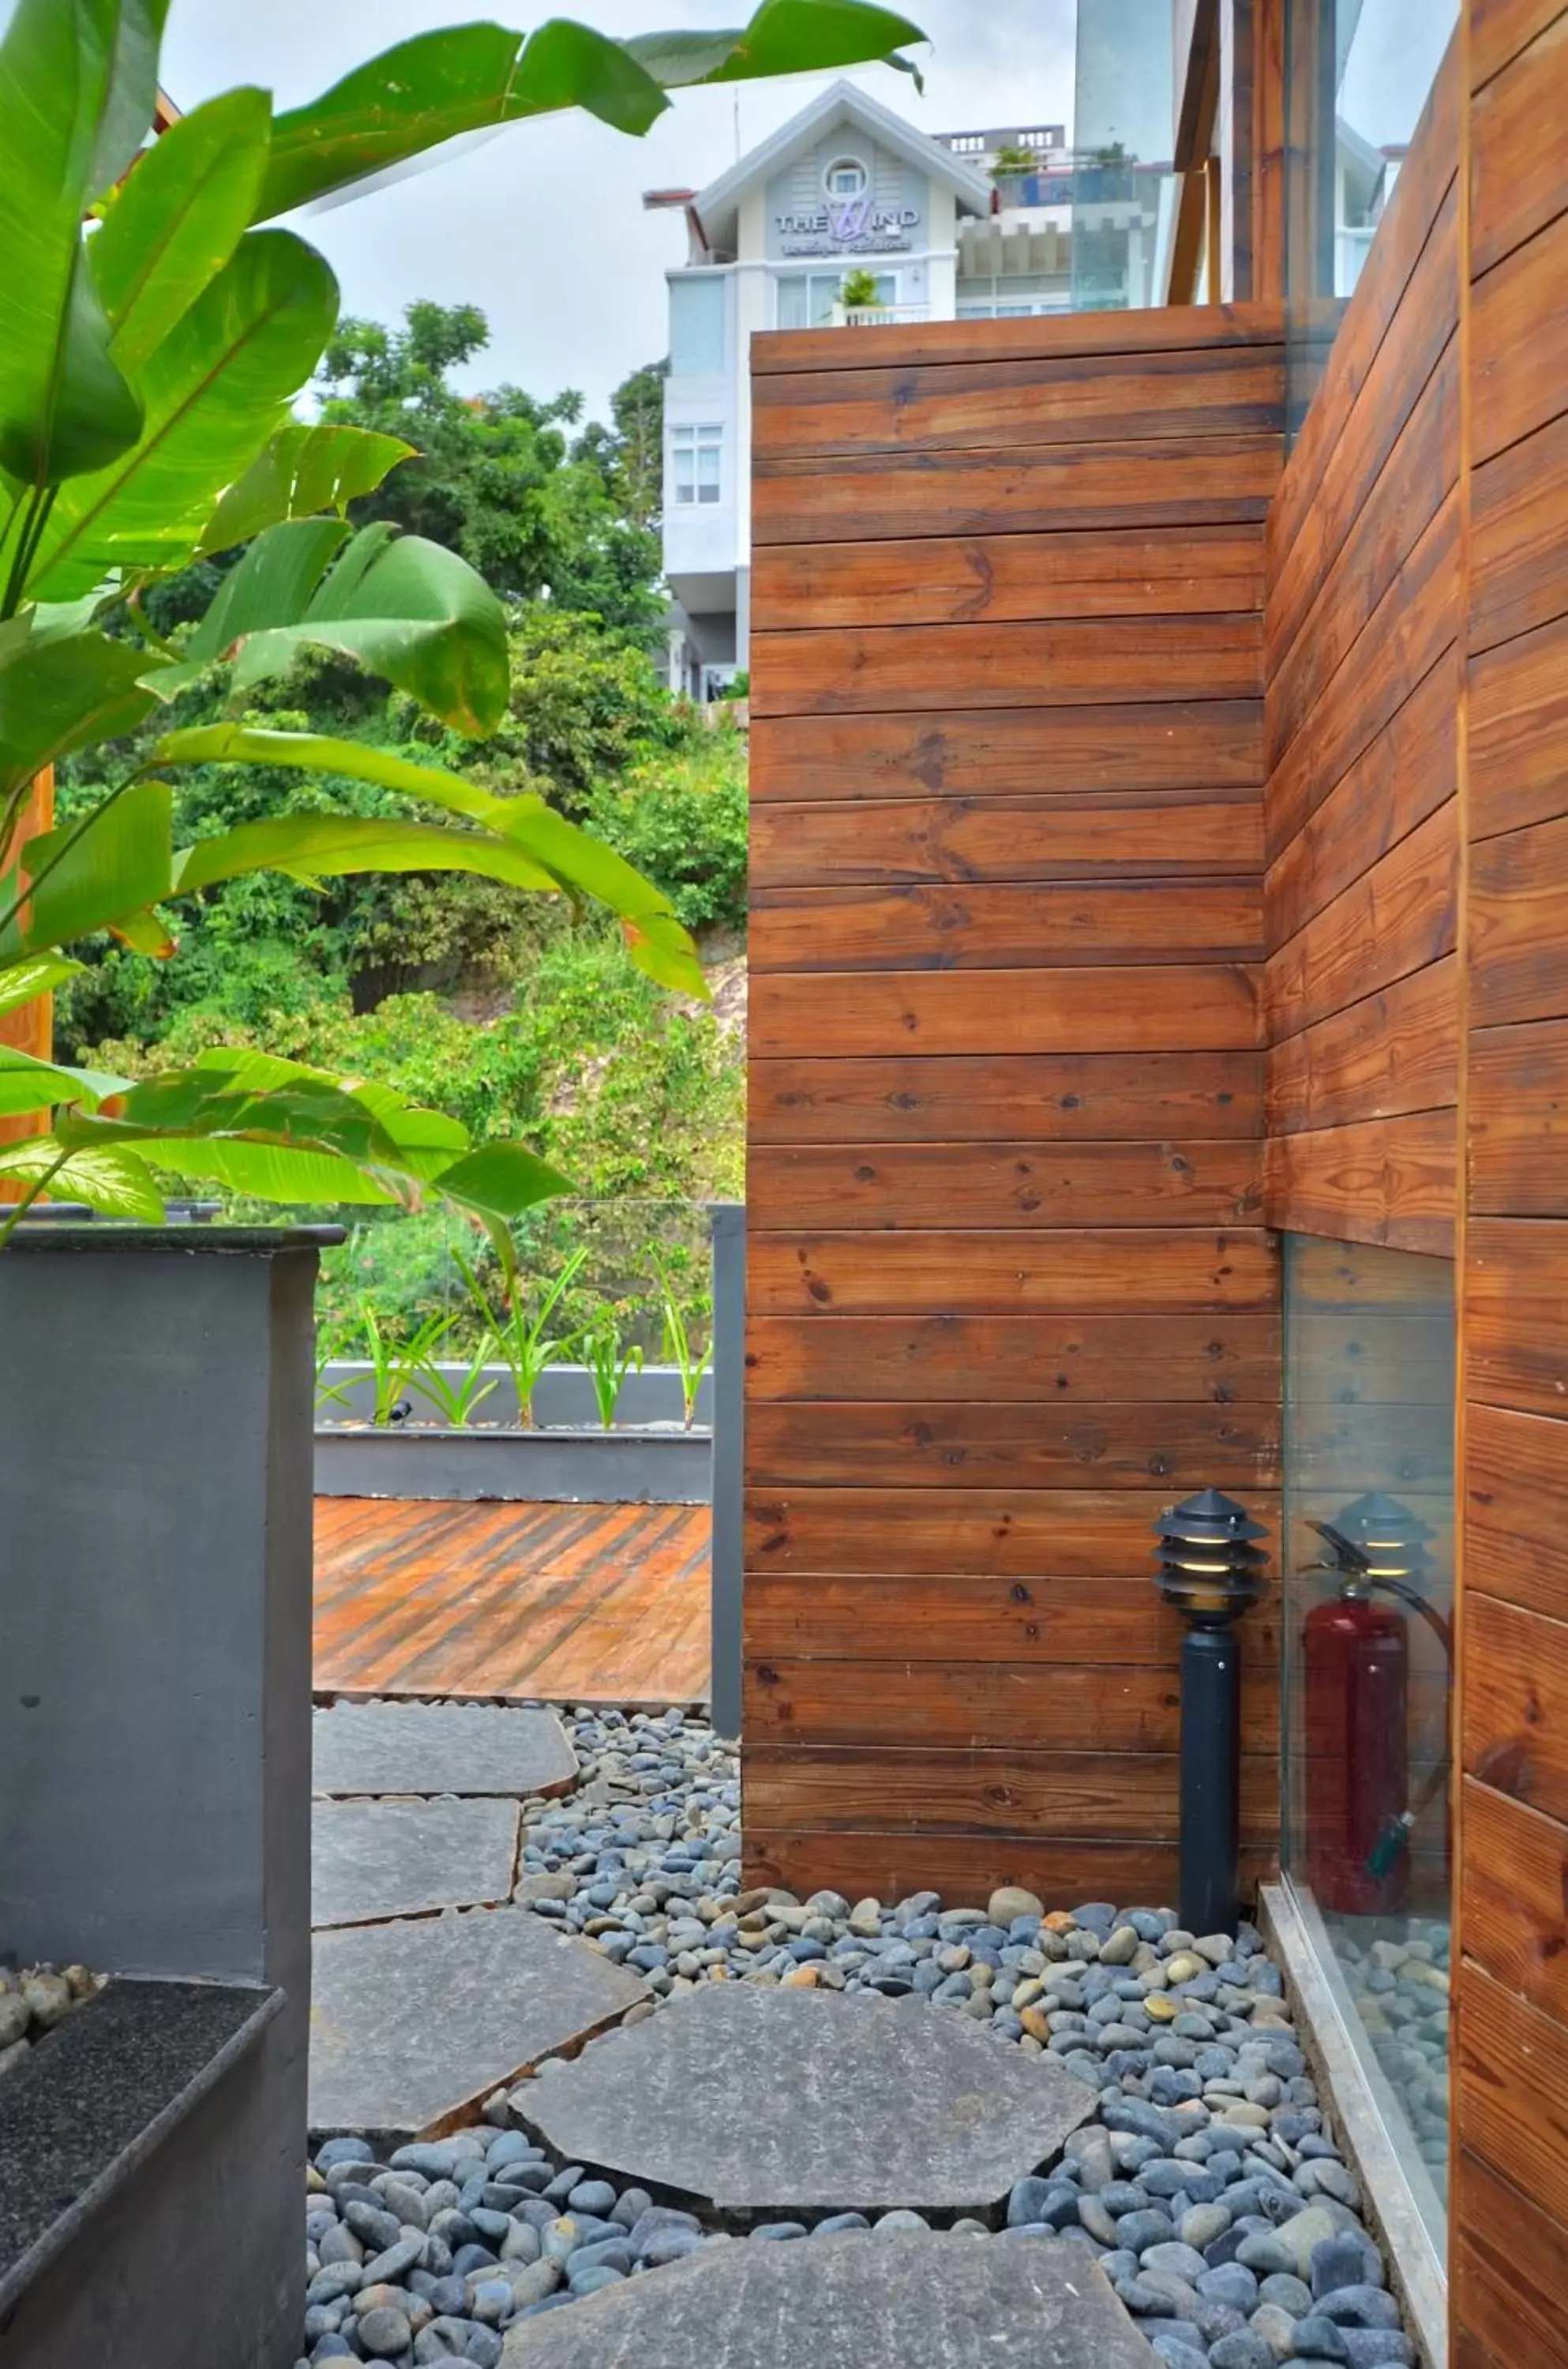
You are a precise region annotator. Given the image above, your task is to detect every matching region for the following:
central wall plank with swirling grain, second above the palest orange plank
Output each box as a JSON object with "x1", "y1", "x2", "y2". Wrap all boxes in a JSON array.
[{"x1": 751, "y1": 789, "x2": 1262, "y2": 900}]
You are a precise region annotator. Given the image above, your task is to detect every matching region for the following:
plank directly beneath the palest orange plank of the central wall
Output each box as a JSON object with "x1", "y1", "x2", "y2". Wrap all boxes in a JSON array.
[{"x1": 746, "y1": 1052, "x2": 1262, "y2": 1144}]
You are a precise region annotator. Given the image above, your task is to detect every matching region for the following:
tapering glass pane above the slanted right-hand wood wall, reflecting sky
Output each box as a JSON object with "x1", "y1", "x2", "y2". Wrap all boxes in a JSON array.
[{"x1": 1286, "y1": 0, "x2": 1459, "y2": 426}]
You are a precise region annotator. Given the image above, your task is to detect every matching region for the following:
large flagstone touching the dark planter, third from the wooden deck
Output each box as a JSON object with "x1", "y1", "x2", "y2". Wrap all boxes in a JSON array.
[{"x1": 310, "y1": 1909, "x2": 647, "y2": 2146}]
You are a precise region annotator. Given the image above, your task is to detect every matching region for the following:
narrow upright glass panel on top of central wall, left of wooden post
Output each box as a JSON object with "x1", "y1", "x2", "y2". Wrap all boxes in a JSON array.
[{"x1": 1071, "y1": 0, "x2": 1175, "y2": 313}]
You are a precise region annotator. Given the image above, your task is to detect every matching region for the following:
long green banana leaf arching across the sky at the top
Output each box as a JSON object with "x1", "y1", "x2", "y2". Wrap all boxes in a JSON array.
[{"x1": 256, "y1": 0, "x2": 924, "y2": 223}]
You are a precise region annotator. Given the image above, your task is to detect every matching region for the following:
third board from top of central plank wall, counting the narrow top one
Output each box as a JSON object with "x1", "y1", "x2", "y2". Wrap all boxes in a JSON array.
[{"x1": 751, "y1": 434, "x2": 1284, "y2": 547}]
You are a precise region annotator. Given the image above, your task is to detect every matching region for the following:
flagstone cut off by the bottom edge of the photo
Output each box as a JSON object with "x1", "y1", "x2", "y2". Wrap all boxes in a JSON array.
[{"x1": 502, "y1": 2227, "x2": 1161, "y2": 2369}]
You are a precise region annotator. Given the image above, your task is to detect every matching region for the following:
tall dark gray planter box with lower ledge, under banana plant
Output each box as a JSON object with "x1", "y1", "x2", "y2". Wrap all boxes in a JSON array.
[{"x1": 0, "y1": 1225, "x2": 339, "y2": 2369}]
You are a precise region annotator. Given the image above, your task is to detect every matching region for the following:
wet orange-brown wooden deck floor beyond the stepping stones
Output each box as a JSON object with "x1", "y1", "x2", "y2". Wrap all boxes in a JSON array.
[{"x1": 315, "y1": 1497, "x2": 711, "y2": 1706}]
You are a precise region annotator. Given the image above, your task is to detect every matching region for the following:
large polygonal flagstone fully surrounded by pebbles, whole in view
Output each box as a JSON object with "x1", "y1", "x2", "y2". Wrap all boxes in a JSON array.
[{"x1": 512, "y1": 1983, "x2": 1094, "y2": 2217}]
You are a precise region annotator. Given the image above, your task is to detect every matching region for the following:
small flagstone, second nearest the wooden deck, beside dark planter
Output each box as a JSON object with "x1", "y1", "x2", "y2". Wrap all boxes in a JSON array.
[{"x1": 310, "y1": 1800, "x2": 519, "y2": 1926}]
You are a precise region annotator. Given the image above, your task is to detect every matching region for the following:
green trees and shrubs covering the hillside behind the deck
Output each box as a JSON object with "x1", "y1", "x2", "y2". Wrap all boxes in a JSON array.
[{"x1": 54, "y1": 303, "x2": 746, "y2": 1322}]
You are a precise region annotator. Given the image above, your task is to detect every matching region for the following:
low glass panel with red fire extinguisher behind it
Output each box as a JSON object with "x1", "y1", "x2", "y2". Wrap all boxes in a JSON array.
[{"x1": 1281, "y1": 1234, "x2": 1454, "y2": 2243}]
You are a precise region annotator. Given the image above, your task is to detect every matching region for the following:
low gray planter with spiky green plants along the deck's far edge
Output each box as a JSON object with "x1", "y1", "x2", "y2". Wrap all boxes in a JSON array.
[{"x1": 315, "y1": 1362, "x2": 713, "y2": 1504}]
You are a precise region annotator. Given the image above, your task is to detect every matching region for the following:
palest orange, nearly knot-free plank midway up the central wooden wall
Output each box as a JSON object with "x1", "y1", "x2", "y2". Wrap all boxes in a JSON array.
[{"x1": 751, "y1": 962, "x2": 1260, "y2": 1059}]
